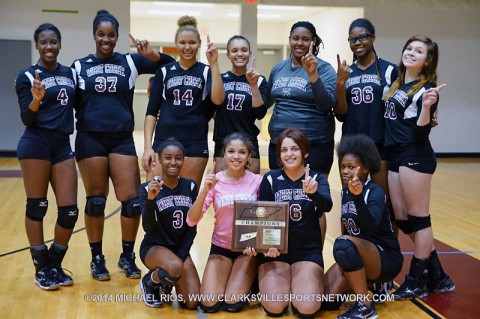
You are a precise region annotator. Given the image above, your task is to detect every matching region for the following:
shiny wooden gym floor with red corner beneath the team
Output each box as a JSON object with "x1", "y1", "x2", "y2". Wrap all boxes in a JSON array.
[{"x1": 0, "y1": 147, "x2": 480, "y2": 319}]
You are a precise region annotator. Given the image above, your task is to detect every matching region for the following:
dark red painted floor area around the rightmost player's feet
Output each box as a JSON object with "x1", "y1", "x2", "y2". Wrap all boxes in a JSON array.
[{"x1": 395, "y1": 233, "x2": 480, "y2": 319}]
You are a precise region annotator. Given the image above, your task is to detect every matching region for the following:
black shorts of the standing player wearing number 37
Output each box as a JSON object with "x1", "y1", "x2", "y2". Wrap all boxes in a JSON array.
[{"x1": 75, "y1": 131, "x2": 137, "y2": 161}]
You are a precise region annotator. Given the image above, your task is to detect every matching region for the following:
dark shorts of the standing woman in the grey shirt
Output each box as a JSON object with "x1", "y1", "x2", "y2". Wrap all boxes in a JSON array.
[{"x1": 268, "y1": 141, "x2": 335, "y2": 174}]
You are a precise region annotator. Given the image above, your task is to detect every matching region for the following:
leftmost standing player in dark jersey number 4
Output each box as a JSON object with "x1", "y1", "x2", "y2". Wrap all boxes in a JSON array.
[{"x1": 15, "y1": 23, "x2": 78, "y2": 290}]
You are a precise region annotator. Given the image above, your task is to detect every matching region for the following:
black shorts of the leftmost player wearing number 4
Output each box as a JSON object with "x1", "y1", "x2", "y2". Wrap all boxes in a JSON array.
[{"x1": 17, "y1": 128, "x2": 74, "y2": 164}]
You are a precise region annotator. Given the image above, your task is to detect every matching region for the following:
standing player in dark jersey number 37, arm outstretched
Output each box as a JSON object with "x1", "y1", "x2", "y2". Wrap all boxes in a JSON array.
[{"x1": 73, "y1": 10, "x2": 173, "y2": 280}]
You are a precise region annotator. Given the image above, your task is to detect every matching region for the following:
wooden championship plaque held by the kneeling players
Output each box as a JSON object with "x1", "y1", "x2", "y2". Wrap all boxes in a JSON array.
[{"x1": 232, "y1": 200, "x2": 289, "y2": 253}]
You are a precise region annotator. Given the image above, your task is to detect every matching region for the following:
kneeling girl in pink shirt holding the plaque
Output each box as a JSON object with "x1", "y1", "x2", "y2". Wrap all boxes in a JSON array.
[{"x1": 187, "y1": 133, "x2": 262, "y2": 313}]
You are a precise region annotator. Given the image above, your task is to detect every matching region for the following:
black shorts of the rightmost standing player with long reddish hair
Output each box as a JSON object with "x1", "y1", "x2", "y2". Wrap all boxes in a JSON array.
[{"x1": 387, "y1": 143, "x2": 437, "y2": 174}]
